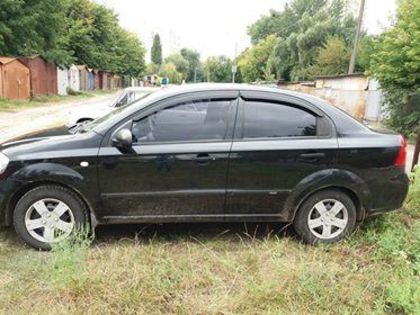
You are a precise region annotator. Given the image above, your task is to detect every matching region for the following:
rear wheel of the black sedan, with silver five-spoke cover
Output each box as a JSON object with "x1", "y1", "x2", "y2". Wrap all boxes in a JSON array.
[{"x1": 293, "y1": 189, "x2": 357, "y2": 244}]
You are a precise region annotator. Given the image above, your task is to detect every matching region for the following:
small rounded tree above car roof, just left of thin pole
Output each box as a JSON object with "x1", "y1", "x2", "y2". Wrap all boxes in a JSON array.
[{"x1": 203, "y1": 56, "x2": 232, "y2": 82}]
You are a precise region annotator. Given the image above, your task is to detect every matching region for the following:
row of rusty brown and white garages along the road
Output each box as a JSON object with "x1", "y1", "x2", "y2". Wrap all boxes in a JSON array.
[{"x1": 0, "y1": 55, "x2": 137, "y2": 100}]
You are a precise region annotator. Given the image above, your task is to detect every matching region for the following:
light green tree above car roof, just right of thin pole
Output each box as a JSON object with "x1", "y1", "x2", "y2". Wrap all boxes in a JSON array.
[{"x1": 238, "y1": 34, "x2": 276, "y2": 82}]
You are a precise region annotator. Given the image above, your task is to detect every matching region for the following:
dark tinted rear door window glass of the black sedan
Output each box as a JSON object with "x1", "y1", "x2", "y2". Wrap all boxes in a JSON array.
[{"x1": 242, "y1": 101, "x2": 317, "y2": 138}]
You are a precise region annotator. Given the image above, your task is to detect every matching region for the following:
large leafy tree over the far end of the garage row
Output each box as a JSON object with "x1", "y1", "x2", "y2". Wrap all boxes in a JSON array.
[{"x1": 58, "y1": 0, "x2": 145, "y2": 76}]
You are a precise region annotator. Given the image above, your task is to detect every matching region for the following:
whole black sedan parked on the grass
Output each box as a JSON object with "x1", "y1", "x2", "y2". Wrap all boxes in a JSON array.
[{"x1": 0, "y1": 84, "x2": 409, "y2": 249}]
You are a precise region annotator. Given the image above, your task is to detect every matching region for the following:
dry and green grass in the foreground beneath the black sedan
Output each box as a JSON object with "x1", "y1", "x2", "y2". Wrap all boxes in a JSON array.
[{"x1": 0, "y1": 169, "x2": 420, "y2": 314}]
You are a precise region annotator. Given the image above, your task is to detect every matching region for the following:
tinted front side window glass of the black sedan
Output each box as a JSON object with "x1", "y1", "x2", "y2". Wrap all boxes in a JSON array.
[{"x1": 132, "y1": 100, "x2": 233, "y2": 142}]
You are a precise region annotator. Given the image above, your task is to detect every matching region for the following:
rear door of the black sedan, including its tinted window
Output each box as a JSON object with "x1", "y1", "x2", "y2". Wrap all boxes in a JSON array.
[{"x1": 226, "y1": 93, "x2": 337, "y2": 220}]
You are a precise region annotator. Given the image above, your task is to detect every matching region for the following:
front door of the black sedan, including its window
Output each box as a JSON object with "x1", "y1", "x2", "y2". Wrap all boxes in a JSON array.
[{"x1": 99, "y1": 91, "x2": 238, "y2": 221}]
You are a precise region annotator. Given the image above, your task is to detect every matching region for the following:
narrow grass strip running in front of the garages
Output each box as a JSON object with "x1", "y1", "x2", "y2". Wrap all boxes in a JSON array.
[{"x1": 0, "y1": 90, "x2": 115, "y2": 112}]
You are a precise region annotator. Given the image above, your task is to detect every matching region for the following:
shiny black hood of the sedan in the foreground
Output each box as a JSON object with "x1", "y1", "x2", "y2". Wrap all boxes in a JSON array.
[{"x1": 0, "y1": 128, "x2": 103, "y2": 160}]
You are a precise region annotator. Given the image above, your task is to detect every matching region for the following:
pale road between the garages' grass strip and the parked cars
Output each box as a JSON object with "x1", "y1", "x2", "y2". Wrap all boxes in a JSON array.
[{"x1": 0, "y1": 93, "x2": 116, "y2": 143}]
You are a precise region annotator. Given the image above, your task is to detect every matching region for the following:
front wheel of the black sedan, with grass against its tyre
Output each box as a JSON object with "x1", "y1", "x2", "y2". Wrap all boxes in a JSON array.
[{"x1": 13, "y1": 185, "x2": 90, "y2": 250}]
